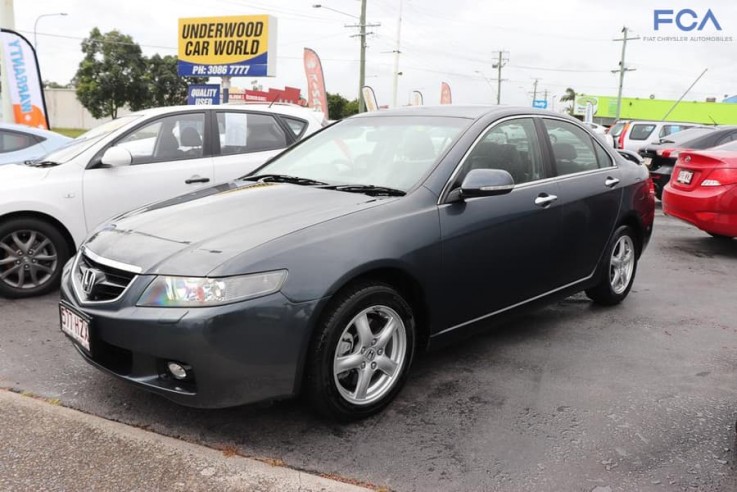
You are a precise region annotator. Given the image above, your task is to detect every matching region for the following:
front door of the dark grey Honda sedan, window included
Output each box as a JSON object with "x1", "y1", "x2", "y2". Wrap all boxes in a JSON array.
[{"x1": 439, "y1": 117, "x2": 561, "y2": 327}]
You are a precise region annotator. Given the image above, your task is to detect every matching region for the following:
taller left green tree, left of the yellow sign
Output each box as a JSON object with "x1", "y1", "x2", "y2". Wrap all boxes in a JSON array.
[{"x1": 74, "y1": 27, "x2": 148, "y2": 118}]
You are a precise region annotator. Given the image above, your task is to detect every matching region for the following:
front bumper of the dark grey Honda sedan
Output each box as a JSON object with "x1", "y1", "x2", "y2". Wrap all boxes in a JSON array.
[{"x1": 61, "y1": 265, "x2": 319, "y2": 408}]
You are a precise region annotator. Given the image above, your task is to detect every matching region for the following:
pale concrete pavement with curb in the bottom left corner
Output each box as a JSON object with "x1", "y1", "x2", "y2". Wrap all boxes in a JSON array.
[{"x1": 0, "y1": 390, "x2": 369, "y2": 492}]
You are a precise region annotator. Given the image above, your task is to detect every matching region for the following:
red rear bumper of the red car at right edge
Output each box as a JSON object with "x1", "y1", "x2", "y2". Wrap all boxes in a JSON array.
[{"x1": 663, "y1": 185, "x2": 737, "y2": 237}]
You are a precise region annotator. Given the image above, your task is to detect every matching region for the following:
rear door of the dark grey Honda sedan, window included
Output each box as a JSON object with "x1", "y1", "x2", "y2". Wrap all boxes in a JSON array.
[{"x1": 541, "y1": 118, "x2": 622, "y2": 285}]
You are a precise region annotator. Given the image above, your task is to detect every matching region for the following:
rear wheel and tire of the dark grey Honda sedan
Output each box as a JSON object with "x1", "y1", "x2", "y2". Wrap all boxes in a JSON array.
[{"x1": 586, "y1": 226, "x2": 637, "y2": 306}]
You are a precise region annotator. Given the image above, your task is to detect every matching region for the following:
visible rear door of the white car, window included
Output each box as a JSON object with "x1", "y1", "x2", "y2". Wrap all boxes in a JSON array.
[{"x1": 213, "y1": 109, "x2": 294, "y2": 182}]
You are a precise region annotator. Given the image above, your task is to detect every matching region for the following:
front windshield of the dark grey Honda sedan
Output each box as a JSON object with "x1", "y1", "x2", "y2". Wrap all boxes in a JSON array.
[{"x1": 253, "y1": 115, "x2": 471, "y2": 191}]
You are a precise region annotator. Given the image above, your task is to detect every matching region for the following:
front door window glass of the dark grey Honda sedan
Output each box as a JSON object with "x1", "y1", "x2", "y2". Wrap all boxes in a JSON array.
[{"x1": 455, "y1": 118, "x2": 545, "y2": 186}]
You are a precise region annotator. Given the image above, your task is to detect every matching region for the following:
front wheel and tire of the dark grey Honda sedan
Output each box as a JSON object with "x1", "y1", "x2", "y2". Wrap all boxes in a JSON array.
[{"x1": 306, "y1": 282, "x2": 416, "y2": 421}]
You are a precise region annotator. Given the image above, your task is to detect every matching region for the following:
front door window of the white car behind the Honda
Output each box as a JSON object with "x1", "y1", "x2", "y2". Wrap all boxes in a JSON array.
[{"x1": 115, "y1": 113, "x2": 205, "y2": 165}]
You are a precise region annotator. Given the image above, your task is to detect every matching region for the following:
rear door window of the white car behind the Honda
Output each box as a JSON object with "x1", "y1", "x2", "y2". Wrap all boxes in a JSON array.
[{"x1": 217, "y1": 111, "x2": 287, "y2": 155}]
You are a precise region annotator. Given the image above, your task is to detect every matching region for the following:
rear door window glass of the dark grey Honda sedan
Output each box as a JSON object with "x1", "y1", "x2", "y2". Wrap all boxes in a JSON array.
[{"x1": 543, "y1": 119, "x2": 599, "y2": 175}]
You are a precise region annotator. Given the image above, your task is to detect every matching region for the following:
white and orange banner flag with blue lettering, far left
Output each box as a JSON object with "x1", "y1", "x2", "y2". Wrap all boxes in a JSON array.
[{"x1": 0, "y1": 29, "x2": 49, "y2": 129}]
